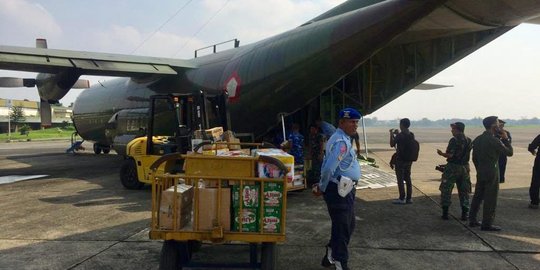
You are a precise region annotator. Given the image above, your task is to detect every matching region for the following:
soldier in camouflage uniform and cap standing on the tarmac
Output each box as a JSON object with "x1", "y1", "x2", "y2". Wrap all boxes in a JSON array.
[{"x1": 437, "y1": 122, "x2": 472, "y2": 221}]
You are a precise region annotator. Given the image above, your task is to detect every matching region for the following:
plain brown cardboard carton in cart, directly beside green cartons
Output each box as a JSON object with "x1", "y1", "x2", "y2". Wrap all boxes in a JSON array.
[{"x1": 195, "y1": 188, "x2": 231, "y2": 231}]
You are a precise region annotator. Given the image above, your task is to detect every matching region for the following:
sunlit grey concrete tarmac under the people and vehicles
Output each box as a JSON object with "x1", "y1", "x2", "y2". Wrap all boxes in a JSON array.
[{"x1": 0, "y1": 128, "x2": 540, "y2": 269}]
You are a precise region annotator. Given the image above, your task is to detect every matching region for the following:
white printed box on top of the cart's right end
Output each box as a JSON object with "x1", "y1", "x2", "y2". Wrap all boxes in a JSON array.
[{"x1": 254, "y1": 148, "x2": 294, "y2": 187}]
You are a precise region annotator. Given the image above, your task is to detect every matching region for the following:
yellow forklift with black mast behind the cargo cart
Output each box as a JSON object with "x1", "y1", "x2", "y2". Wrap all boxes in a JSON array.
[{"x1": 120, "y1": 91, "x2": 228, "y2": 189}]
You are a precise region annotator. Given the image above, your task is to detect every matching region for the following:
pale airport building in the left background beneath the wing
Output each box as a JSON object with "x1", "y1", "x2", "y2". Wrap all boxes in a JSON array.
[{"x1": 0, "y1": 98, "x2": 73, "y2": 133}]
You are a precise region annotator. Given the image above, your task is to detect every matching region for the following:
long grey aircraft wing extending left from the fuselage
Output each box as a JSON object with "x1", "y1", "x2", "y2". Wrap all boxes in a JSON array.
[{"x1": 0, "y1": 46, "x2": 196, "y2": 77}]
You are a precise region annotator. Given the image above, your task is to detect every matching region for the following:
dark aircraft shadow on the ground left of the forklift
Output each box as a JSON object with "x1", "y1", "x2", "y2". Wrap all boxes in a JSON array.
[{"x1": 0, "y1": 153, "x2": 151, "y2": 212}]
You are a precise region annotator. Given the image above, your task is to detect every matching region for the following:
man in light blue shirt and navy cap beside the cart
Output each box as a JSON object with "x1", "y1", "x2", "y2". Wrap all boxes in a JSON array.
[{"x1": 319, "y1": 108, "x2": 361, "y2": 270}]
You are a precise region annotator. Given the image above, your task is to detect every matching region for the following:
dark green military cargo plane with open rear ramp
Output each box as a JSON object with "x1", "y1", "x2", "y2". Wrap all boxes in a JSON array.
[{"x1": 0, "y1": 0, "x2": 540, "y2": 153}]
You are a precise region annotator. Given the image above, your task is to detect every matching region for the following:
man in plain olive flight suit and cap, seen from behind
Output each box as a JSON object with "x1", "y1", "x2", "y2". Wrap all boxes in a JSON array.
[{"x1": 469, "y1": 116, "x2": 514, "y2": 231}]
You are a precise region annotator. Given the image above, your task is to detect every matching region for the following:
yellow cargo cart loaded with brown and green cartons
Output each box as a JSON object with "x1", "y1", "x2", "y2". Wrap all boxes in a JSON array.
[{"x1": 149, "y1": 146, "x2": 287, "y2": 269}]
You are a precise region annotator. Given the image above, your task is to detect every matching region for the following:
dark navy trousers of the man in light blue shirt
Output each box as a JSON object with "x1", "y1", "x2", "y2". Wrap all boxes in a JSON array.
[{"x1": 324, "y1": 182, "x2": 356, "y2": 263}]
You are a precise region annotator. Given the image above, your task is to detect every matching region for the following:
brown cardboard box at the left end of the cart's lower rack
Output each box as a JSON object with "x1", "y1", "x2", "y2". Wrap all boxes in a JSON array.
[{"x1": 159, "y1": 184, "x2": 193, "y2": 230}]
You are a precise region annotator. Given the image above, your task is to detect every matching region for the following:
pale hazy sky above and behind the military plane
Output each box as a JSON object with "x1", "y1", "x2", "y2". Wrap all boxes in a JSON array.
[{"x1": 0, "y1": 0, "x2": 540, "y2": 120}]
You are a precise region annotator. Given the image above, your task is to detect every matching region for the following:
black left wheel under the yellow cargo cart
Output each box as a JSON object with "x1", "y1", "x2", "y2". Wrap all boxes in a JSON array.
[{"x1": 159, "y1": 240, "x2": 191, "y2": 270}]
